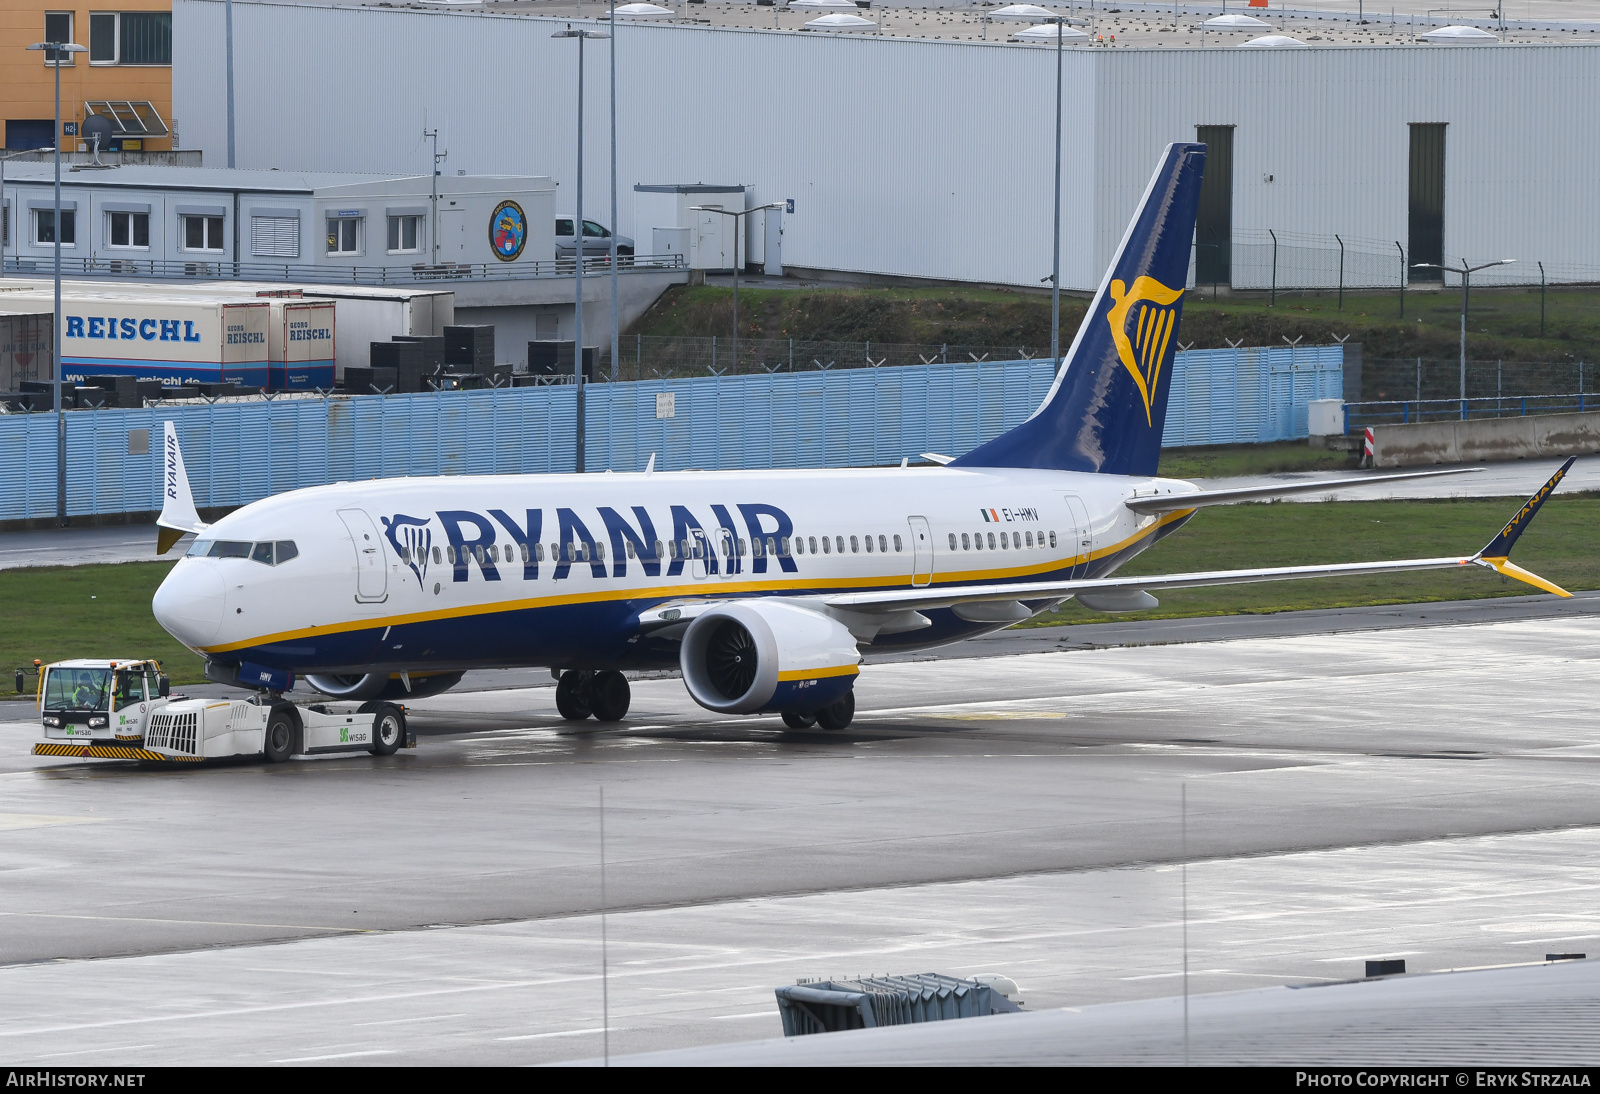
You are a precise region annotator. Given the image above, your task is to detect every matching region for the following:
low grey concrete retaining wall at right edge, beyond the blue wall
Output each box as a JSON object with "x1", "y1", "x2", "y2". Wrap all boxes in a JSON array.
[{"x1": 1373, "y1": 413, "x2": 1600, "y2": 467}]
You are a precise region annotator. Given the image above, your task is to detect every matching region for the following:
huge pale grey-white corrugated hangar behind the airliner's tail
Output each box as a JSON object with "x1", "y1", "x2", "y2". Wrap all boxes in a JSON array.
[{"x1": 173, "y1": 0, "x2": 1600, "y2": 289}]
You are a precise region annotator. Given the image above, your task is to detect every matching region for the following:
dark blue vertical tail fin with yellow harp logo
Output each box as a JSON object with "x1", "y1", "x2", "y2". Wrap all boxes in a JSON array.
[{"x1": 950, "y1": 144, "x2": 1205, "y2": 475}]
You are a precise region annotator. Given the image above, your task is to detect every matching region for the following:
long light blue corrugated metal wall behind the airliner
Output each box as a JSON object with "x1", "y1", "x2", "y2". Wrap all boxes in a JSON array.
[{"x1": 0, "y1": 345, "x2": 1344, "y2": 520}]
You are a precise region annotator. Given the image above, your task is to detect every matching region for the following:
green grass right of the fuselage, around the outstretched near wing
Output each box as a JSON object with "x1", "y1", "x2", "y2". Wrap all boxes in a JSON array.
[{"x1": 1027, "y1": 494, "x2": 1600, "y2": 625}]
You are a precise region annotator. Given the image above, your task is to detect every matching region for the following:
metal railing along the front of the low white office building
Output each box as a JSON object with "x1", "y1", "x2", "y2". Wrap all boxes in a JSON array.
[{"x1": 3, "y1": 254, "x2": 688, "y2": 285}]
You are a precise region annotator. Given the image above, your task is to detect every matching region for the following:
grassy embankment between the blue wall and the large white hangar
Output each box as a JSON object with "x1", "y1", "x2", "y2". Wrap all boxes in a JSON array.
[{"x1": 629, "y1": 285, "x2": 1600, "y2": 361}]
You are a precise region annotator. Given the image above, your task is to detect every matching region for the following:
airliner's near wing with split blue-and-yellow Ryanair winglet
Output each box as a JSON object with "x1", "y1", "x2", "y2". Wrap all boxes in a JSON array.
[{"x1": 822, "y1": 459, "x2": 1574, "y2": 613}]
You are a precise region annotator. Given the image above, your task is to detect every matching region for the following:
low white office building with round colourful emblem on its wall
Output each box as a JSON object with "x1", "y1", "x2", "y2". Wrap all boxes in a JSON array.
[{"x1": 0, "y1": 167, "x2": 555, "y2": 278}]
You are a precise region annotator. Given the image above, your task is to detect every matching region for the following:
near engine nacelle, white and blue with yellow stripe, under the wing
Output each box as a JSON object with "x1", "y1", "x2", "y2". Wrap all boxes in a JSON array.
[{"x1": 678, "y1": 600, "x2": 861, "y2": 713}]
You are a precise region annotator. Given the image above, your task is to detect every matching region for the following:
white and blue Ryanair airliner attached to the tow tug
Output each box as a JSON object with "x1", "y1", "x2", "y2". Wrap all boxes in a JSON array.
[{"x1": 154, "y1": 144, "x2": 1571, "y2": 729}]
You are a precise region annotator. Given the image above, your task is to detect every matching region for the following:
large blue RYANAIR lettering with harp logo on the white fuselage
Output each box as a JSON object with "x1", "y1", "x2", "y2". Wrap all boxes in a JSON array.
[{"x1": 381, "y1": 502, "x2": 798, "y2": 587}]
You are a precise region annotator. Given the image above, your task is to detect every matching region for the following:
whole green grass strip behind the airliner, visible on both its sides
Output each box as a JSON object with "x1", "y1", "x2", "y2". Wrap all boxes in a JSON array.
[{"x1": 0, "y1": 492, "x2": 1600, "y2": 683}]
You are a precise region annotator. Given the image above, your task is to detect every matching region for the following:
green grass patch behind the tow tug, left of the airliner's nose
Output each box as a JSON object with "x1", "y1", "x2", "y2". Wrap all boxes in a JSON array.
[{"x1": 0, "y1": 561, "x2": 205, "y2": 694}]
